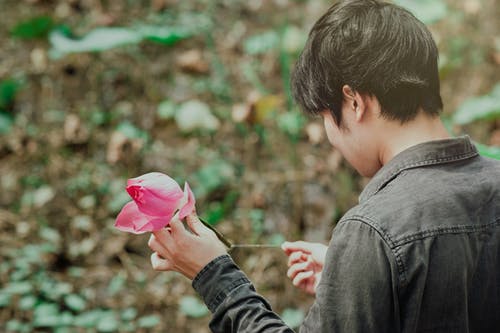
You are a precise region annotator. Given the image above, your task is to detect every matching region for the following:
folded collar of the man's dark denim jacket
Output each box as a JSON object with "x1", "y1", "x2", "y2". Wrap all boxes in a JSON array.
[{"x1": 359, "y1": 135, "x2": 478, "y2": 203}]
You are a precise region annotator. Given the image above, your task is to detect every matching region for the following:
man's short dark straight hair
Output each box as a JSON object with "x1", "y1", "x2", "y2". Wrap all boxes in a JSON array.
[{"x1": 292, "y1": 0, "x2": 443, "y2": 125}]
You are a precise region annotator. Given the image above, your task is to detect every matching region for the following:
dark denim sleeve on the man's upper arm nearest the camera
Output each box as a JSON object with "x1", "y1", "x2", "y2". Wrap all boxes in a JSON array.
[{"x1": 300, "y1": 220, "x2": 400, "y2": 333}]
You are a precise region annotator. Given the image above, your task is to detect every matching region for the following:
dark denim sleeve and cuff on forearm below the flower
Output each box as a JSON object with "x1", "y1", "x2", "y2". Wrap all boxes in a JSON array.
[{"x1": 193, "y1": 255, "x2": 293, "y2": 333}]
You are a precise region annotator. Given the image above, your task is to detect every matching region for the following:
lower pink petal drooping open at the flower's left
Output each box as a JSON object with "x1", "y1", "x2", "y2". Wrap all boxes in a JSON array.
[{"x1": 115, "y1": 201, "x2": 171, "y2": 234}]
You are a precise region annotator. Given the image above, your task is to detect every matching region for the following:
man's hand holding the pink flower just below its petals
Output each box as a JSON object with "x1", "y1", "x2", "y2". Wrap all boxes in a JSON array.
[{"x1": 148, "y1": 213, "x2": 227, "y2": 280}]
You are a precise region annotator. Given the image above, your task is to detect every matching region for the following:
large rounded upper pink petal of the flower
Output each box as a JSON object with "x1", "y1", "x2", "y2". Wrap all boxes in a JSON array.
[{"x1": 127, "y1": 172, "x2": 183, "y2": 216}]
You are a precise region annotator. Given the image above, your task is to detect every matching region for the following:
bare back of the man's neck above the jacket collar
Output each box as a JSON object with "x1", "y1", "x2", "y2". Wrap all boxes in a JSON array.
[{"x1": 379, "y1": 112, "x2": 450, "y2": 165}]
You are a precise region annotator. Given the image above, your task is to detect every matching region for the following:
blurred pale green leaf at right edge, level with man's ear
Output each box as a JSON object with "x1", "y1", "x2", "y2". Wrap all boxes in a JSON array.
[{"x1": 452, "y1": 83, "x2": 500, "y2": 125}]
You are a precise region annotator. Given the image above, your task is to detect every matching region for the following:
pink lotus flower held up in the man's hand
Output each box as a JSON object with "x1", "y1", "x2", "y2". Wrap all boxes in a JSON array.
[{"x1": 115, "y1": 172, "x2": 196, "y2": 234}]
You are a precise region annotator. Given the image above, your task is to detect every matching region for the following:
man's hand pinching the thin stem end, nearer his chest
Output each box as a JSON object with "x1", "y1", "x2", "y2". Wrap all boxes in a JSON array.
[{"x1": 281, "y1": 241, "x2": 327, "y2": 295}]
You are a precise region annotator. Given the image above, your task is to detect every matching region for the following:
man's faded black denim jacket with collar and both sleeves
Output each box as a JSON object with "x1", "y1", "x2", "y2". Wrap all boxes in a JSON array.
[{"x1": 193, "y1": 137, "x2": 500, "y2": 333}]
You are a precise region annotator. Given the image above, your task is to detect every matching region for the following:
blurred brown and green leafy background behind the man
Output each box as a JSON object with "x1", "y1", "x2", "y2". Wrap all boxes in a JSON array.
[{"x1": 0, "y1": 0, "x2": 500, "y2": 332}]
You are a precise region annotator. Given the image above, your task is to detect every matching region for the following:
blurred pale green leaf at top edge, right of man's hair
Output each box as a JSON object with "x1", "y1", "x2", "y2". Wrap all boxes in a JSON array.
[{"x1": 394, "y1": 0, "x2": 448, "y2": 24}]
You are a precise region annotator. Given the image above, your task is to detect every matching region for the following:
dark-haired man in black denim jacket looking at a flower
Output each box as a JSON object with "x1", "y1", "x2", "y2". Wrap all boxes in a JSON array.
[{"x1": 149, "y1": 0, "x2": 500, "y2": 333}]
